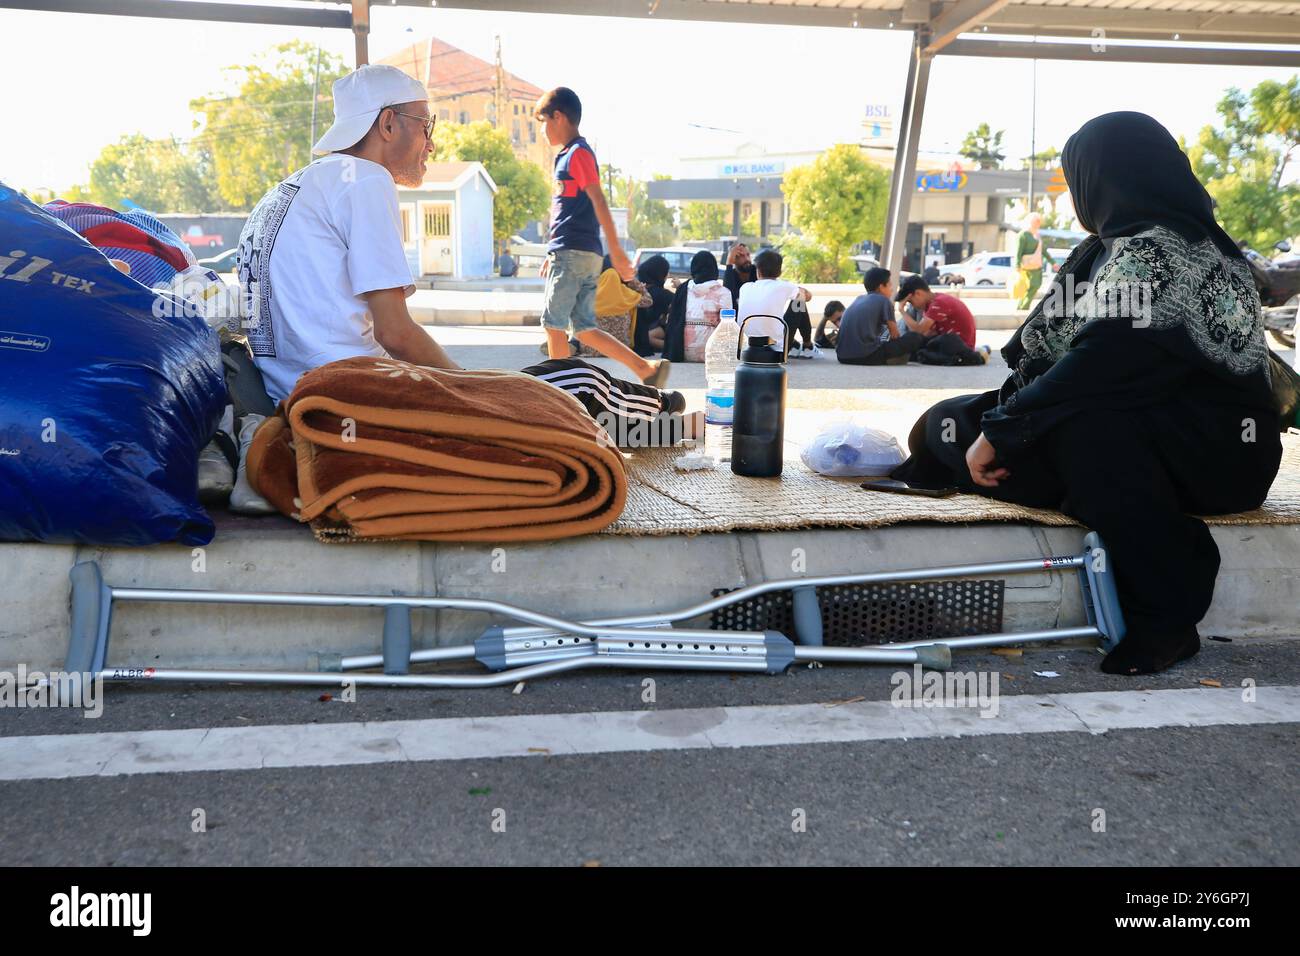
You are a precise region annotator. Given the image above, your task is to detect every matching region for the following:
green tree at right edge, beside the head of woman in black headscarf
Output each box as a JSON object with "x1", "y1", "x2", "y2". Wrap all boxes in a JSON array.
[{"x1": 1179, "y1": 75, "x2": 1300, "y2": 251}]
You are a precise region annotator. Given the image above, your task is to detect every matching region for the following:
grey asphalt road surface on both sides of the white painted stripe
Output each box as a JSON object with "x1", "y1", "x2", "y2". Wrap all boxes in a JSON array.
[{"x1": 0, "y1": 640, "x2": 1300, "y2": 866}]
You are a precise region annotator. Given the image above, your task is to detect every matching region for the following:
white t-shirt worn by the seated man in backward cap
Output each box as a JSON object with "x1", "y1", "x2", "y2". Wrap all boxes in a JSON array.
[{"x1": 238, "y1": 152, "x2": 415, "y2": 402}]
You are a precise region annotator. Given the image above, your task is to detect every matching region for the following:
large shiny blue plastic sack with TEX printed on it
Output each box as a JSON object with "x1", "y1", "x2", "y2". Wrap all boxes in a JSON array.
[{"x1": 0, "y1": 183, "x2": 226, "y2": 545}]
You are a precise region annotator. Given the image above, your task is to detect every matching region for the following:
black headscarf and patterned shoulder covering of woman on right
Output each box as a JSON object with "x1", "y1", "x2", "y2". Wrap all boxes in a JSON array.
[{"x1": 1002, "y1": 112, "x2": 1269, "y2": 392}]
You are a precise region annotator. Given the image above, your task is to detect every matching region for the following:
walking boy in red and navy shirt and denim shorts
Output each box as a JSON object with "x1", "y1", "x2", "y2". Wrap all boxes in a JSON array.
[{"x1": 534, "y1": 86, "x2": 670, "y2": 388}]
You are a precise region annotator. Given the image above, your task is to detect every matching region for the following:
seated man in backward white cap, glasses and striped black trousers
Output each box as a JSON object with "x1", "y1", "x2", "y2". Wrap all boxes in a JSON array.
[{"x1": 231, "y1": 65, "x2": 685, "y2": 447}]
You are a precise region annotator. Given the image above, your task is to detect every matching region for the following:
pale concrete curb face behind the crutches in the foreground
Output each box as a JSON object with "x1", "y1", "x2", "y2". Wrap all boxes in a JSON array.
[{"x1": 0, "y1": 519, "x2": 1300, "y2": 670}]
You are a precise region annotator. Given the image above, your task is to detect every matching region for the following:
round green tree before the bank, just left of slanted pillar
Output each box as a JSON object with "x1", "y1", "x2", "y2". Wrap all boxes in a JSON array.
[{"x1": 781, "y1": 143, "x2": 889, "y2": 274}]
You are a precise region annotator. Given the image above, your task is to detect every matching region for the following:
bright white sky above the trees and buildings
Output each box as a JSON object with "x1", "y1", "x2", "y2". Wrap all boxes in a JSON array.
[{"x1": 0, "y1": 3, "x2": 1296, "y2": 195}]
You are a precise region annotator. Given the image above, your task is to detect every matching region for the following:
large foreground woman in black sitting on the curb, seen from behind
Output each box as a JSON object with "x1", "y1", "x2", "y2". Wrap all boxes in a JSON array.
[{"x1": 893, "y1": 112, "x2": 1282, "y2": 674}]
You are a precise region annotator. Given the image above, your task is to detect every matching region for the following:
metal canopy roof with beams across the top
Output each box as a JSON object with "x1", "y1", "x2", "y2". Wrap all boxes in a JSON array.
[{"x1": 0, "y1": 0, "x2": 1300, "y2": 66}]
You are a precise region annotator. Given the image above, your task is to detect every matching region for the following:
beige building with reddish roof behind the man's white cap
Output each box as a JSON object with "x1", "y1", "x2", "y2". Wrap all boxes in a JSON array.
[{"x1": 380, "y1": 36, "x2": 555, "y2": 177}]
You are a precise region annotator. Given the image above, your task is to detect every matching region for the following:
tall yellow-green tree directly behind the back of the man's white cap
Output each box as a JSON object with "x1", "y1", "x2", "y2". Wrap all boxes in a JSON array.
[{"x1": 190, "y1": 40, "x2": 347, "y2": 209}]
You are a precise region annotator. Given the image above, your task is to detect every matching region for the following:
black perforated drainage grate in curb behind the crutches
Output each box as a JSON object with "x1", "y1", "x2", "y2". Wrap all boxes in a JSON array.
[{"x1": 709, "y1": 580, "x2": 1006, "y2": 648}]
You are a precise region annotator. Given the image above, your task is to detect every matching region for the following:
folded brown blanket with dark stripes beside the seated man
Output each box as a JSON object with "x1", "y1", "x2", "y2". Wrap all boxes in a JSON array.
[{"x1": 247, "y1": 356, "x2": 628, "y2": 541}]
